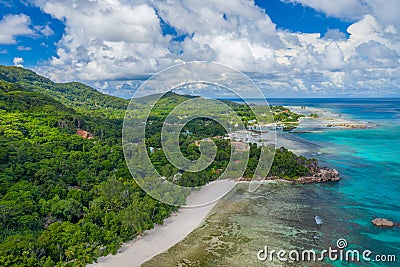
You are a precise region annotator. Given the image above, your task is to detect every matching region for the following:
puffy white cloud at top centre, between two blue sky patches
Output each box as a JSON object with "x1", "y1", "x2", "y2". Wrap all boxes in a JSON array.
[{"x1": 154, "y1": 0, "x2": 281, "y2": 71}]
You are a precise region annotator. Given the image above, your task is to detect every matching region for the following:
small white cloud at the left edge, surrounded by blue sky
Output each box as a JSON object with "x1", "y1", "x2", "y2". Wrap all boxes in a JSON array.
[{"x1": 0, "y1": 14, "x2": 34, "y2": 44}]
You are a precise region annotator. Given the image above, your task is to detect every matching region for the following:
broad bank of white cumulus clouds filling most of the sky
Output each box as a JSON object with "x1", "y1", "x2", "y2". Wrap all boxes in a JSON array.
[{"x1": 30, "y1": 0, "x2": 400, "y2": 95}]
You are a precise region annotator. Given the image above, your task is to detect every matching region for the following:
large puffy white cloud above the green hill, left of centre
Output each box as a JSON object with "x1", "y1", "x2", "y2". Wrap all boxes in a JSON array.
[{"x1": 37, "y1": 0, "x2": 173, "y2": 80}]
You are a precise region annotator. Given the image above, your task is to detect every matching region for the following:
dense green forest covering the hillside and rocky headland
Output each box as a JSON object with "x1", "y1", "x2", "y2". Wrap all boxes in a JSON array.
[{"x1": 0, "y1": 66, "x2": 318, "y2": 266}]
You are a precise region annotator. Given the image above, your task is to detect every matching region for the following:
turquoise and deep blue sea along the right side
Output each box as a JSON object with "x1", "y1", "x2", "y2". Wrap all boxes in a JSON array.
[{"x1": 268, "y1": 98, "x2": 400, "y2": 266}]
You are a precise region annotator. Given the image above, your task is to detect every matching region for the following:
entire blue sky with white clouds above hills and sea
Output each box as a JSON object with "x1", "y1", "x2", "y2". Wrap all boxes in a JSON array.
[{"x1": 0, "y1": 0, "x2": 400, "y2": 97}]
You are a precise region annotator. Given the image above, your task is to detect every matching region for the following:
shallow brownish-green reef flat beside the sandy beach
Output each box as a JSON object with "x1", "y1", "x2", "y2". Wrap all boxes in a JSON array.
[{"x1": 143, "y1": 181, "x2": 327, "y2": 267}]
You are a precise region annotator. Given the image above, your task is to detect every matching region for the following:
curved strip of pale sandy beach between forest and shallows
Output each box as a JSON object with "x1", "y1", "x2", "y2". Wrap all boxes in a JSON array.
[{"x1": 88, "y1": 180, "x2": 237, "y2": 267}]
